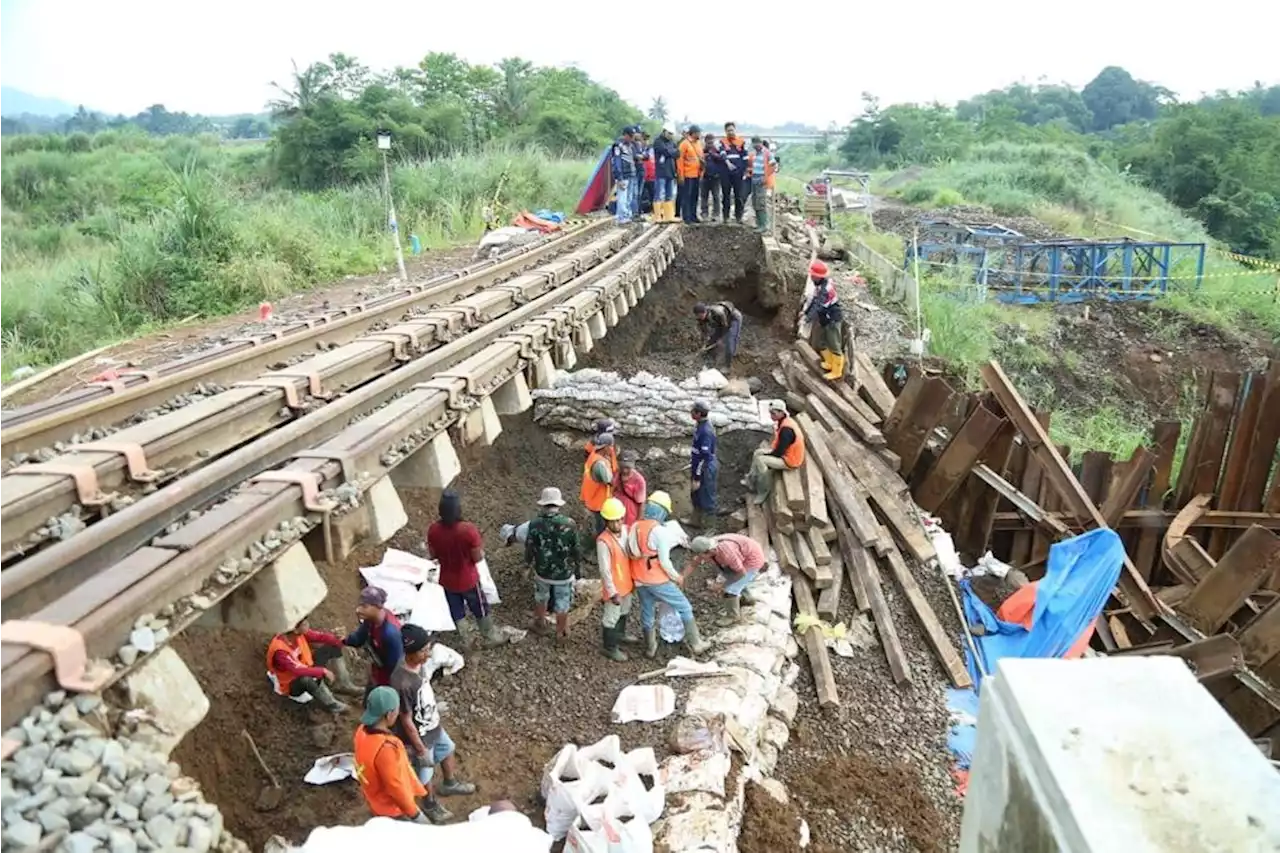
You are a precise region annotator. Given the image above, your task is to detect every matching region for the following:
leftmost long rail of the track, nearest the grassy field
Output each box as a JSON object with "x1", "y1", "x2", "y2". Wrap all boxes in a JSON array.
[{"x1": 0, "y1": 220, "x2": 609, "y2": 457}]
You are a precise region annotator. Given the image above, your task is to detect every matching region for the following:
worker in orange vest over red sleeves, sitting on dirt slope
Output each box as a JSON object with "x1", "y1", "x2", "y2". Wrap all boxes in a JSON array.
[{"x1": 266, "y1": 617, "x2": 361, "y2": 713}]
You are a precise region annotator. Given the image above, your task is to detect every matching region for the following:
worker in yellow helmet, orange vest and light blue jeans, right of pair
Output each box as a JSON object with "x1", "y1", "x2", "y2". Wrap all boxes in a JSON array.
[{"x1": 627, "y1": 492, "x2": 712, "y2": 657}]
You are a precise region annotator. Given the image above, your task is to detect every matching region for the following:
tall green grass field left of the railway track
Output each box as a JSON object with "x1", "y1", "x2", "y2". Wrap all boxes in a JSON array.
[{"x1": 0, "y1": 134, "x2": 593, "y2": 371}]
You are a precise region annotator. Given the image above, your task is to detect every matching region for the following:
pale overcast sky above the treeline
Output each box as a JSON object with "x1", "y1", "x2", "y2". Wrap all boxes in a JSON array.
[{"x1": 0, "y1": 0, "x2": 1280, "y2": 126}]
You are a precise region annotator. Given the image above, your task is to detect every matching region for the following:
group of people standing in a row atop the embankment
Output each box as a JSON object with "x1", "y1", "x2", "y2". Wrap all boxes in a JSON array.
[{"x1": 611, "y1": 122, "x2": 778, "y2": 233}]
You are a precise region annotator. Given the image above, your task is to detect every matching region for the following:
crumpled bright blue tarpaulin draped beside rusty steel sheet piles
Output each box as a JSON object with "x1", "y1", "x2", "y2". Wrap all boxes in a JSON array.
[{"x1": 960, "y1": 528, "x2": 1124, "y2": 688}]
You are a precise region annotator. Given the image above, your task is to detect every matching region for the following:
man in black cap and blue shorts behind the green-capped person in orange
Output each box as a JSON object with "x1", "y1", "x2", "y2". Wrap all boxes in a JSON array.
[{"x1": 390, "y1": 622, "x2": 476, "y2": 824}]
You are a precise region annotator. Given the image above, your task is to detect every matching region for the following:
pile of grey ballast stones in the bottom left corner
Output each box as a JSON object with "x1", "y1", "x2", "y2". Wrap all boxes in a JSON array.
[{"x1": 0, "y1": 692, "x2": 248, "y2": 853}]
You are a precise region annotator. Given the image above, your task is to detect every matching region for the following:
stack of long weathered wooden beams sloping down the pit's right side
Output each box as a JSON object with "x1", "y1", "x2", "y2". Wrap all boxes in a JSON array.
[{"x1": 748, "y1": 342, "x2": 970, "y2": 704}]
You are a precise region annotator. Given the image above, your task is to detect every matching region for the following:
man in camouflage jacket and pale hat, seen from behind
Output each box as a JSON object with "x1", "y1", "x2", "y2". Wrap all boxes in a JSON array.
[{"x1": 525, "y1": 487, "x2": 581, "y2": 642}]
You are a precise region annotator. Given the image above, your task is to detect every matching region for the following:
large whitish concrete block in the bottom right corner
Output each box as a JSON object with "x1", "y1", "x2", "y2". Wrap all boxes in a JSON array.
[{"x1": 960, "y1": 657, "x2": 1280, "y2": 853}]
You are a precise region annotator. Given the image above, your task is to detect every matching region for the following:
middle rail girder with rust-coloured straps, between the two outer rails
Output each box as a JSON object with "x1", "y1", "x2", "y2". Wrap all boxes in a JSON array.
[{"x1": 0, "y1": 222, "x2": 630, "y2": 568}]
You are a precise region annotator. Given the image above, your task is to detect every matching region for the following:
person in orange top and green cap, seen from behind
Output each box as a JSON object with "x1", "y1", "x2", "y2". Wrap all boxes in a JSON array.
[{"x1": 353, "y1": 685, "x2": 431, "y2": 824}]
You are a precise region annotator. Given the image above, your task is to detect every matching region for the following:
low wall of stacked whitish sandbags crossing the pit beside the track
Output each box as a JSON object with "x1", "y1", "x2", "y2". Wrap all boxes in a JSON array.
[{"x1": 532, "y1": 369, "x2": 769, "y2": 438}]
